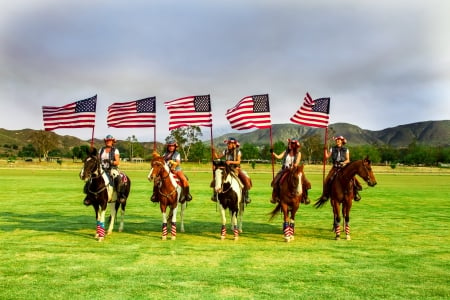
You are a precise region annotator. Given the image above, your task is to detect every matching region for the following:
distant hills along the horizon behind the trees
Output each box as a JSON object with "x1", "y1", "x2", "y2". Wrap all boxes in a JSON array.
[{"x1": 0, "y1": 120, "x2": 450, "y2": 154}]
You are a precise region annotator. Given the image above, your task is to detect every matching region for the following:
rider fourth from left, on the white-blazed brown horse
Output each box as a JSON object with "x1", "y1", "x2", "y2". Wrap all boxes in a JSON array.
[{"x1": 270, "y1": 138, "x2": 311, "y2": 204}]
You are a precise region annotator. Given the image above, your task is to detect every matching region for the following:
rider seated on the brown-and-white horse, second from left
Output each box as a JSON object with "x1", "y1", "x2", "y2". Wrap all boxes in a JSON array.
[{"x1": 150, "y1": 140, "x2": 192, "y2": 203}]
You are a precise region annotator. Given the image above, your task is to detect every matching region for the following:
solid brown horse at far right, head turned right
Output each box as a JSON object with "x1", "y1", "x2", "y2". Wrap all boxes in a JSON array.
[{"x1": 314, "y1": 156, "x2": 377, "y2": 240}]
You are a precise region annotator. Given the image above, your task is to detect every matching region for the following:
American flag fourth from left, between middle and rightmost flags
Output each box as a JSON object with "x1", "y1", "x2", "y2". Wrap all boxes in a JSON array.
[{"x1": 225, "y1": 94, "x2": 272, "y2": 130}]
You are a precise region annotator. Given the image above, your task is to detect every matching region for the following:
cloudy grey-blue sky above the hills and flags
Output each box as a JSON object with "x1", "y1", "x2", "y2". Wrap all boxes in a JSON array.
[{"x1": 0, "y1": 0, "x2": 450, "y2": 141}]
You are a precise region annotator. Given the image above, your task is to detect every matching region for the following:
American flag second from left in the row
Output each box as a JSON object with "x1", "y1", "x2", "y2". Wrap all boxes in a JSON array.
[{"x1": 107, "y1": 97, "x2": 156, "y2": 128}]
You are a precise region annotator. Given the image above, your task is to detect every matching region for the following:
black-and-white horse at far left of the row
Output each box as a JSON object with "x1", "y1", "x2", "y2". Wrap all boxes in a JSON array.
[{"x1": 80, "y1": 148, "x2": 131, "y2": 242}]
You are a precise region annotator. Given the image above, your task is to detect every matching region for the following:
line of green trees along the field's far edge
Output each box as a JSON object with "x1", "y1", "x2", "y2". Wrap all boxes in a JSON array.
[{"x1": 0, "y1": 126, "x2": 450, "y2": 166}]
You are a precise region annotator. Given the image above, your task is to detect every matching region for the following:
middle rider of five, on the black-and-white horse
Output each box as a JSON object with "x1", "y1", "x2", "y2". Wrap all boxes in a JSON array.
[{"x1": 211, "y1": 137, "x2": 252, "y2": 204}]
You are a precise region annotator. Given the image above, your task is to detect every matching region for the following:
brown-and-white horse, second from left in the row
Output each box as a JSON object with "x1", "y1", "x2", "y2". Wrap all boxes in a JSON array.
[{"x1": 147, "y1": 153, "x2": 186, "y2": 240}]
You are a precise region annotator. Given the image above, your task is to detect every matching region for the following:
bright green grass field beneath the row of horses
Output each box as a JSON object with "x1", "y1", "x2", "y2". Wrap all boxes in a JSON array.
[{"x1": 0, "y1": 163, "x2": 450, "y2": 299}]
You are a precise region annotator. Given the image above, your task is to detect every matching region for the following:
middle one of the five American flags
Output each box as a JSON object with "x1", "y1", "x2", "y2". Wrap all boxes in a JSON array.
[{"x1": 164, "y1": 95, "x2": 212, "y2": 130}]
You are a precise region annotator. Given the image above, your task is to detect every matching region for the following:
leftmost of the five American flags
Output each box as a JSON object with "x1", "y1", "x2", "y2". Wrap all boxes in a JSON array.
[{"x1": 42, "y1": 95, "x2": 97, "y2": 131}]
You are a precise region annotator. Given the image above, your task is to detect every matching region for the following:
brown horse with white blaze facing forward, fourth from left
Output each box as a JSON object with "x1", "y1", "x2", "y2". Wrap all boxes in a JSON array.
[{"x1": 270, "y1": 165, "x2": 304, "y2": 242}]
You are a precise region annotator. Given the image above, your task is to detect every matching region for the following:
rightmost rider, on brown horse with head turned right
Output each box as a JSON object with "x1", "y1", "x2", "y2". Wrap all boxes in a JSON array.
[{"x1": 320, "y1": 136, "x2": 362, "y2": 201}]
